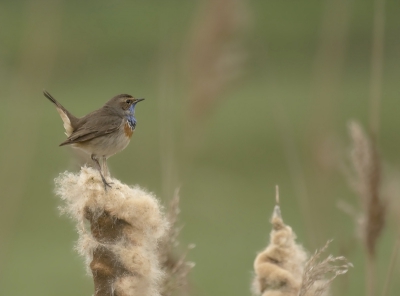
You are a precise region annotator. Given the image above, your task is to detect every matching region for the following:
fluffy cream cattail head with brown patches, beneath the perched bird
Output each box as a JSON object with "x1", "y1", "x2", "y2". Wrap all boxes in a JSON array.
[{"x1": 55, "y1": 167, "x2": 168, "y2": 296}]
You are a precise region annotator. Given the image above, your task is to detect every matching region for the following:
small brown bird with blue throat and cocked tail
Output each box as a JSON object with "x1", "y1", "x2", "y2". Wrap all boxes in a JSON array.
[{"x1": 43, "y1": 90, "x2": 144, "y2": 189}]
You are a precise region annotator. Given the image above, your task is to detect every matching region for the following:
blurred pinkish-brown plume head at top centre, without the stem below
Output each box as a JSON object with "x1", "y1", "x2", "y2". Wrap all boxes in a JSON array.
[{"x1": 188, "y1": 0, "x2": 247, "y2": 118}]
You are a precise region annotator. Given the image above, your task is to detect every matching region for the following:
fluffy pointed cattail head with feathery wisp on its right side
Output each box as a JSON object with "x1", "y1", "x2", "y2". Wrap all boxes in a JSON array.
[{"x1": 253, "y1": 187, "x2": 351, "y2": 296}]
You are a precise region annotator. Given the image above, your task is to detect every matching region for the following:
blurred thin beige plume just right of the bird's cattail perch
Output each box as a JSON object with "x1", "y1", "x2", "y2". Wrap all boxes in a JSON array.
[{"x1": 159, "y1": 190, "x2": 194, "y2": 296}]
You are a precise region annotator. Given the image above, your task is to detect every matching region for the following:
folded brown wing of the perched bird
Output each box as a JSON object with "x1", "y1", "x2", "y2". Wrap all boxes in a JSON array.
[{"x1": 60, "y1": 109, "x2": 123, "y2": 146}]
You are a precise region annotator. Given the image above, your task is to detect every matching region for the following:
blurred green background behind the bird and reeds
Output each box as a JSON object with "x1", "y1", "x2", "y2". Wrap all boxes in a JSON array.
[{"x1": 0, "y1": 0, "x2": 400, "y2": 296}]
